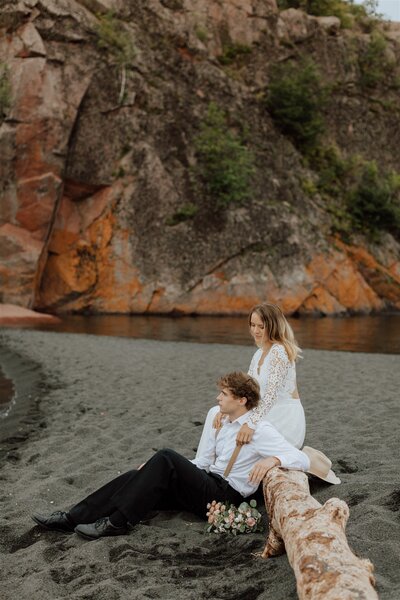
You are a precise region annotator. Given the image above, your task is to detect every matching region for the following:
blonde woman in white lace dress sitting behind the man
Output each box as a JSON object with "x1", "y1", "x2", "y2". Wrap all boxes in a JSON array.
[{"x1": 197, "y1": 304, "x2": 306, "y2": 453}]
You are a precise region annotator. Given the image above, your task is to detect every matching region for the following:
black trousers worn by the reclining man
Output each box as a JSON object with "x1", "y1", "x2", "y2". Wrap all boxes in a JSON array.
[{"x1": 69, "y1": 449, "x2": 244, "y2": 525}]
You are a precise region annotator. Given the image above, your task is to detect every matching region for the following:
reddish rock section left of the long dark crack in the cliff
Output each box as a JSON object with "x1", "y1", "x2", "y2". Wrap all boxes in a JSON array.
[{"x1": 0, "y1": 11, "x2": 95, "y2": 306}]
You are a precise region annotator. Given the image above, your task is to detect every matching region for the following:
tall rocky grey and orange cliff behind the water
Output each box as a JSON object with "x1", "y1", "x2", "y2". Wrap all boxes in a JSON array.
[{"x1": 0, "y1": 0, "x2": 400, "y2": 314}]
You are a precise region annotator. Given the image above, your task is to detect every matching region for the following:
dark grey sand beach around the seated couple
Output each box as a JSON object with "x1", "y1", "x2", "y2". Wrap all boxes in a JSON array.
[{"x1": 0, "y1": 329, "x2": 400, "y2": 600}]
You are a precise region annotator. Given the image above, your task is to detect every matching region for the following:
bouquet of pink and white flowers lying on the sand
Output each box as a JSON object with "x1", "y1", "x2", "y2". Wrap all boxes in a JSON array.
[{"x1": 206, "y1": 500, "x2": 263, "y2": 535}]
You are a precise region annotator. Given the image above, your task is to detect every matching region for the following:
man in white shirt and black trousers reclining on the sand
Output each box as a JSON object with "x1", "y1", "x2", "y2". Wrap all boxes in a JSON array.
[{"x1": 32, "y1": 372, "x2": 309, "y2": 540}]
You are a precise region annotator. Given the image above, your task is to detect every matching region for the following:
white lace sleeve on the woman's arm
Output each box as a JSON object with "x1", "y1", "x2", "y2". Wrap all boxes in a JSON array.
[{"x1": 248, "y1": 344, "x2": 290, "y2": 428}]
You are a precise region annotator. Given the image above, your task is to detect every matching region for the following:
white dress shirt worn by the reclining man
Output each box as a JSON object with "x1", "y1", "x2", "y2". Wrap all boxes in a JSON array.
[{"x1": 191, "y1": 412, "x2": 310, "y2": 497}]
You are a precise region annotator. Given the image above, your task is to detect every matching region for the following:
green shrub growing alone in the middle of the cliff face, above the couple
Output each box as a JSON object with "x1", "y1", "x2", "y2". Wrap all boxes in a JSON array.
[{"x1": 194, "y1": 102, "x2": 255, "y2": 207}]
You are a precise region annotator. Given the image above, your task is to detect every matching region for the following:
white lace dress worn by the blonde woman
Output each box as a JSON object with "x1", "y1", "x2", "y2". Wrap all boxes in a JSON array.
[{"x1": 196, "y1": 344, "x2": 306, "y2": 456}]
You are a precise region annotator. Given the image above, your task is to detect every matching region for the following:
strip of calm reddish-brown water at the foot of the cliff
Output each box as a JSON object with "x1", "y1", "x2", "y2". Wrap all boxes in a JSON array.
[{"x1": 10, "y1": 314, "x2": 400, "y2": 354}]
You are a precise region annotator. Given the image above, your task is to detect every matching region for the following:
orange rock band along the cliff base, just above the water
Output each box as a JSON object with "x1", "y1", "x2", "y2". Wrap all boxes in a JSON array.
[{"x1": 38, "y1": 223, "x2": 400, "y2": 315}]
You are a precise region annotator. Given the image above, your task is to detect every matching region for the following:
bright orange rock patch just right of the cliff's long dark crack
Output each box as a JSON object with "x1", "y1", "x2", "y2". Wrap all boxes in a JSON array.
[{"x1": 37, "y1": 186, "x2": 145, "y2": 313}]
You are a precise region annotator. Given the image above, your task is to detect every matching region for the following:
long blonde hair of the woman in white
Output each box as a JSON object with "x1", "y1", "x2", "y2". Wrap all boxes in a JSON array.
[{"x1": 249, "y1": 303, "x2": 301, "y2": 362}]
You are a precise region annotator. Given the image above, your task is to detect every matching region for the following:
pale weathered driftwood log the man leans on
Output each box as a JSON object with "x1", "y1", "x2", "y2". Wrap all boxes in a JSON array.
[{"x1": 262, "y1": 467, "x2": 378, "y2": 600}]
